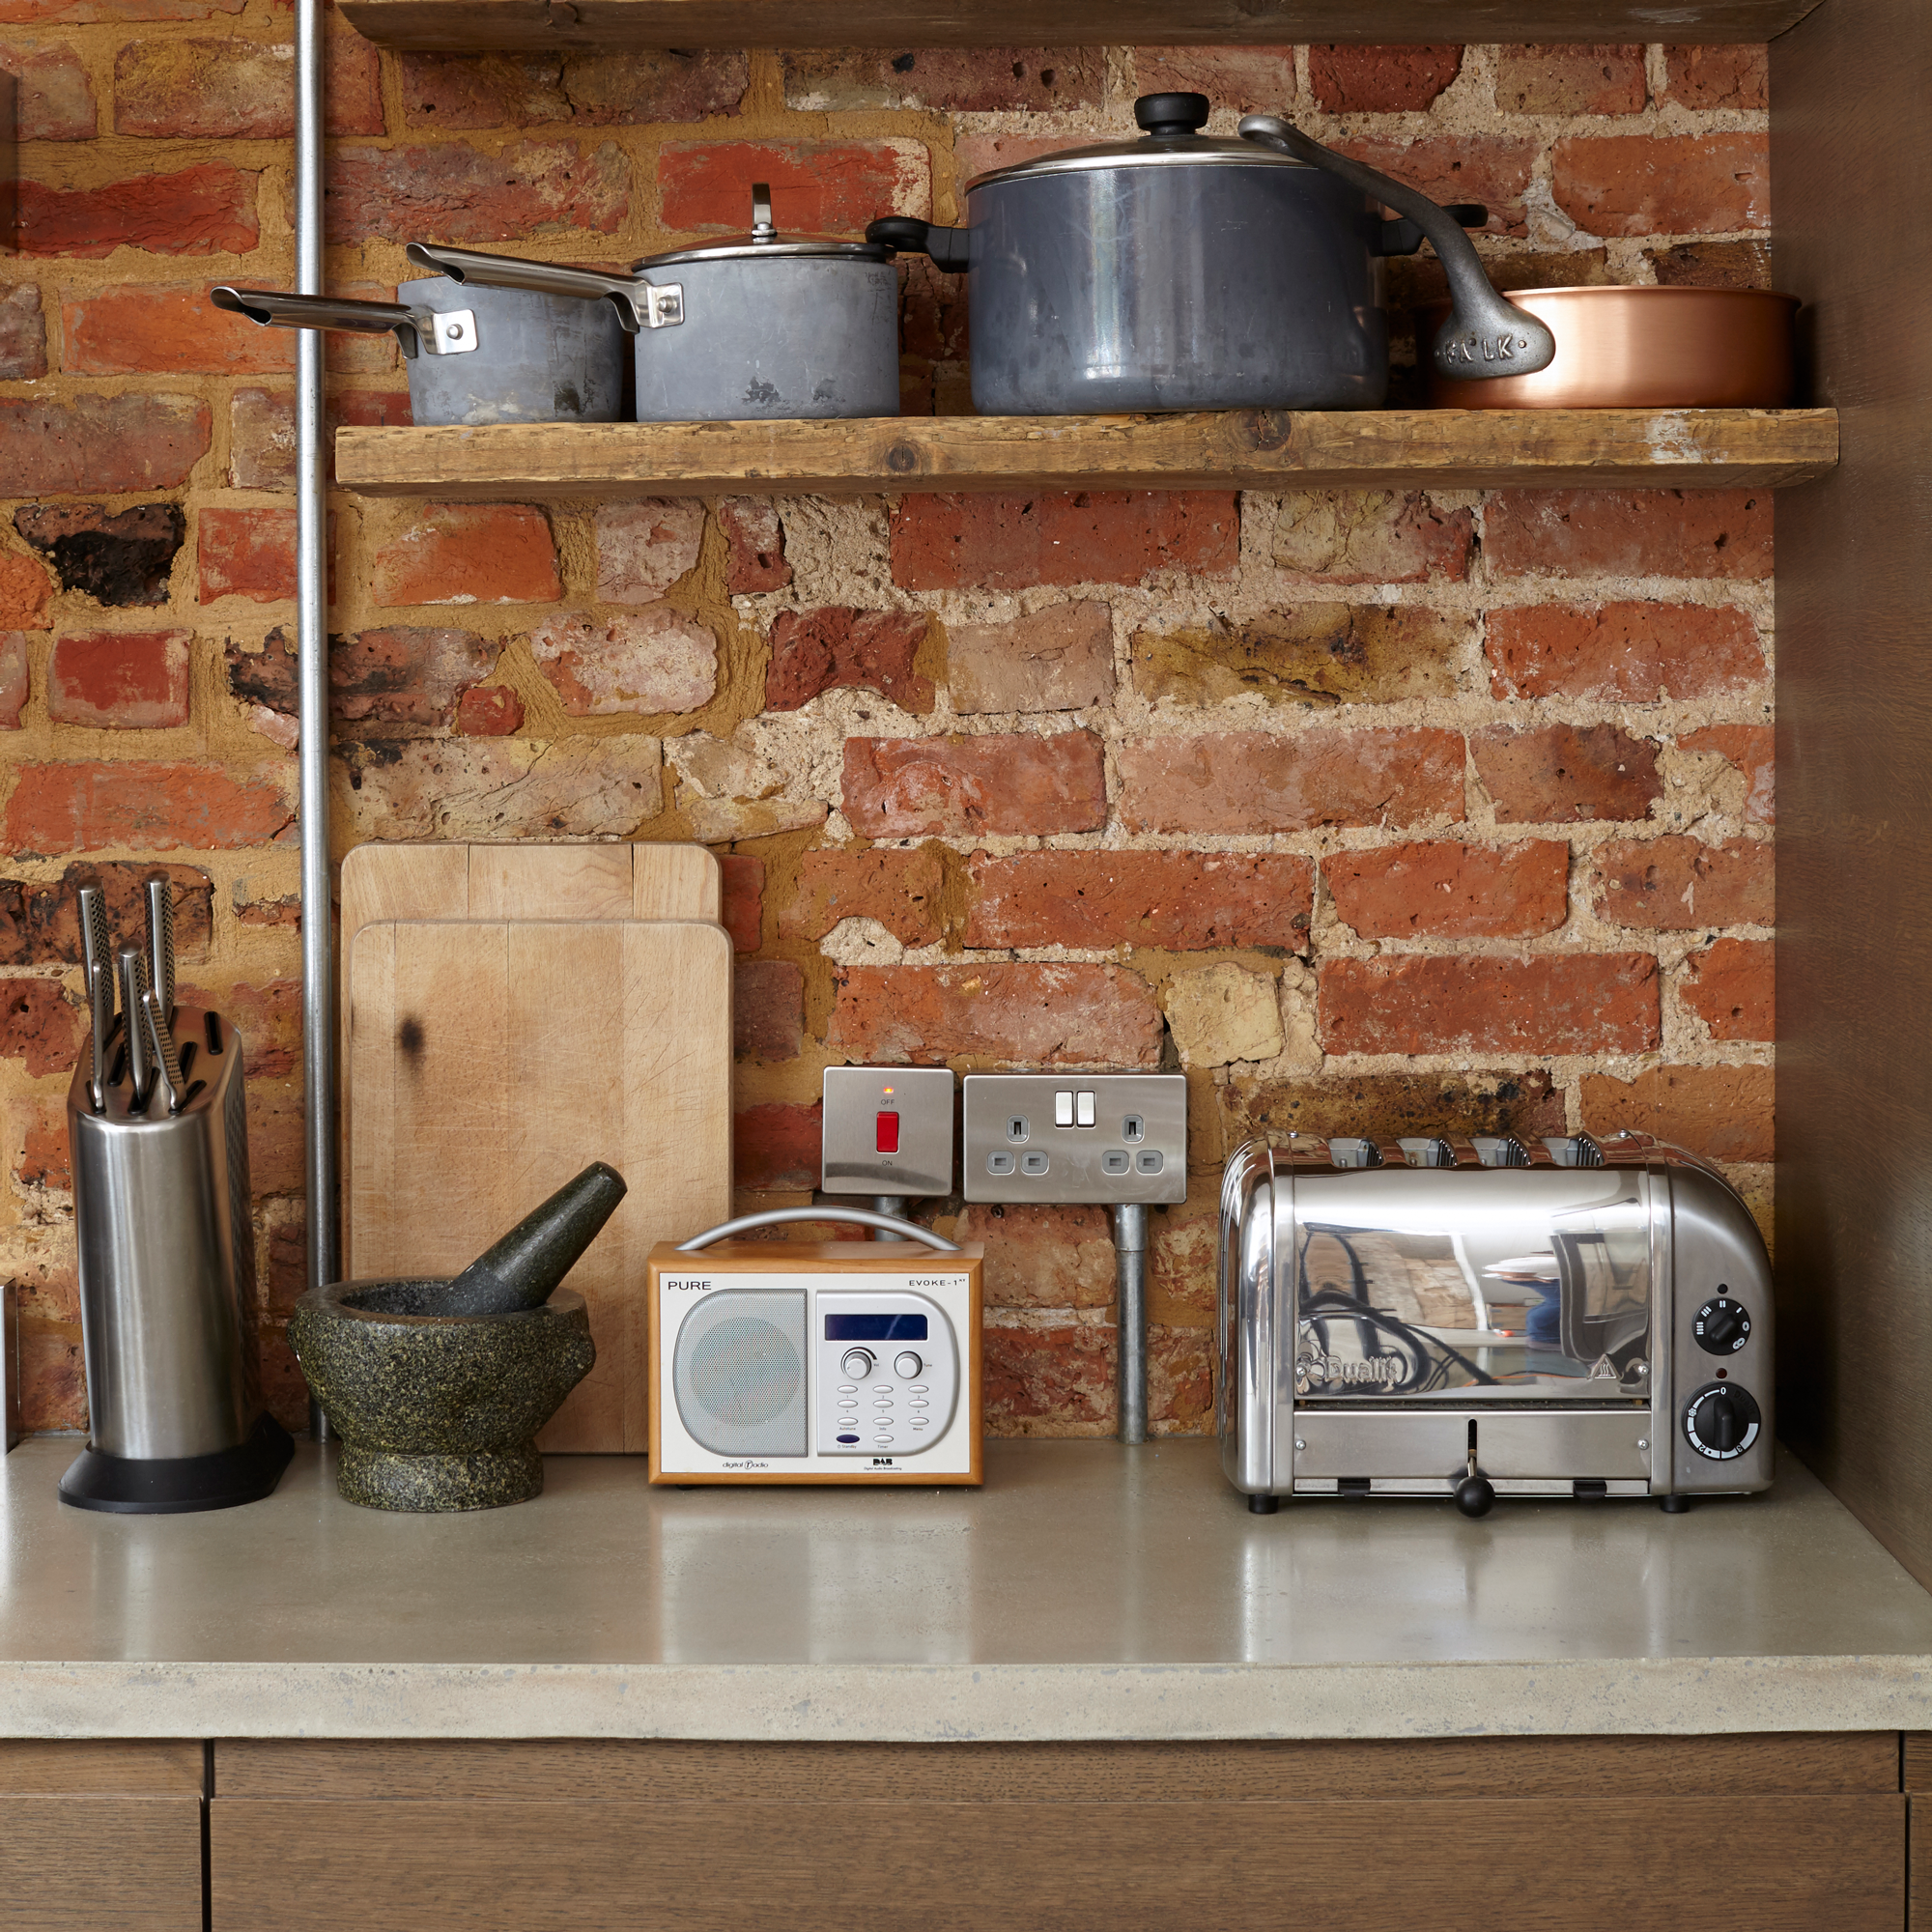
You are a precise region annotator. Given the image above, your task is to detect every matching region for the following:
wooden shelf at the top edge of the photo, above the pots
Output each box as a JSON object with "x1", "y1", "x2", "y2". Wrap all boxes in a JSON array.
[{"x1": 342, "y1": 0, "x2": 1818, "y2": 52}]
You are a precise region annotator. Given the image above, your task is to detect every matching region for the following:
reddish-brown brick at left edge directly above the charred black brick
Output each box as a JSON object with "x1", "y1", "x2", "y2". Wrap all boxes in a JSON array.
[{"x1": 0, "y1": 392, "x2": 211, "y2": 497}]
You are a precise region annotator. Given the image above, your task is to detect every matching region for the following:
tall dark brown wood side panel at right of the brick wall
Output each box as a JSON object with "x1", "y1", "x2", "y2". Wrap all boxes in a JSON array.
[{"x1": 1772, "y1": 0, "x2": 1932, "y2": 1584}]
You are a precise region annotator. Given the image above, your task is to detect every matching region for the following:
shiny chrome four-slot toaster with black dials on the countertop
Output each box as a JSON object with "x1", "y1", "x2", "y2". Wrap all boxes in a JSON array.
[{"x1": 1217, "y1": 1134, "x2": 1772, "y2": 1517}]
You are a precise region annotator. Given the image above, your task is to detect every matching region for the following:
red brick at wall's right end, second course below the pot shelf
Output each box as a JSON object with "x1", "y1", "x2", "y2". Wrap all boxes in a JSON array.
[{"x1": 1484, "y1": 603, "x2": 1768, "y2": 705}]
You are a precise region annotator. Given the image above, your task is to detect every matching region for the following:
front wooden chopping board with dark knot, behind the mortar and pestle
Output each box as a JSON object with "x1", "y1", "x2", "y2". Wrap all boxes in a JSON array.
[{"x1": 344, "y1": 916, "x2": 732, "y2": 1453}]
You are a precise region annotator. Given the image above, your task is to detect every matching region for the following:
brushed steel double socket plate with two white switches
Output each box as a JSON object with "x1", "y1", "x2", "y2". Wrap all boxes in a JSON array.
[{"x1": 962, "y1": 1072, "x2": 1188, "y2": 1206}]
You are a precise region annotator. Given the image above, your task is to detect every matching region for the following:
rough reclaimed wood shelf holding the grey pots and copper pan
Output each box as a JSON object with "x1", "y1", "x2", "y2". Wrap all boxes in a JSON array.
[{"x1": 336, "y1": 410, "x2": 1837, "y2": 502}]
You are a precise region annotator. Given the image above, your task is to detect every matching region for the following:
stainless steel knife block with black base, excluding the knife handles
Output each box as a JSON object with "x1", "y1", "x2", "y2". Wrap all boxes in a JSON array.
[{"x1": 60, "y1": 1007, "x2": 294, "y2": 1515}]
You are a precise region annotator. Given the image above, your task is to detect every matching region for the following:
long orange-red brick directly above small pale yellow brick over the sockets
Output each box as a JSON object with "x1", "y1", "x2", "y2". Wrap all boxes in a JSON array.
[{"x1": 966, "y1": 852, "x2": 1314, "y2": 952}]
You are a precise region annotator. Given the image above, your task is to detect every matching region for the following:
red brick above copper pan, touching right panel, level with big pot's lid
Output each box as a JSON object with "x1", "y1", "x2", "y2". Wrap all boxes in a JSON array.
[{"x1": 1549, "y1": 133, "x2": 1772, "y2": 236}]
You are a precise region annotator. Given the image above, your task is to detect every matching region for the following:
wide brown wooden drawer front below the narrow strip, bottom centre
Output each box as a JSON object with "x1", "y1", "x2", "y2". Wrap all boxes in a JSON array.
[{"x1": 209, "y1": 1791, "x2": 1905, "y2": 1932}]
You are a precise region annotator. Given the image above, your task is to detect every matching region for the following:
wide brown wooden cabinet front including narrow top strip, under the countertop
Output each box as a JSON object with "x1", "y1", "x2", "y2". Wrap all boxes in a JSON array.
[{"x1": 209, "y1": 1731, "x2": 1907, "y2": 1932}]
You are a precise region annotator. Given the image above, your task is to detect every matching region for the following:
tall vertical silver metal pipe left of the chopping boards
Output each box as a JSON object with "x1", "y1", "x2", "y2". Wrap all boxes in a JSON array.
[{"x1": 296, "y1": 0, "x2": 340, "y2": 1441}]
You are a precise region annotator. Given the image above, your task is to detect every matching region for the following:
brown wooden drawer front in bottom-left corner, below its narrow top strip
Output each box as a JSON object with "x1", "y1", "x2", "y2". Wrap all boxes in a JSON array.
[{"x1": 0, "y1": 1793, "x2": 201, "y2": 1932}]
